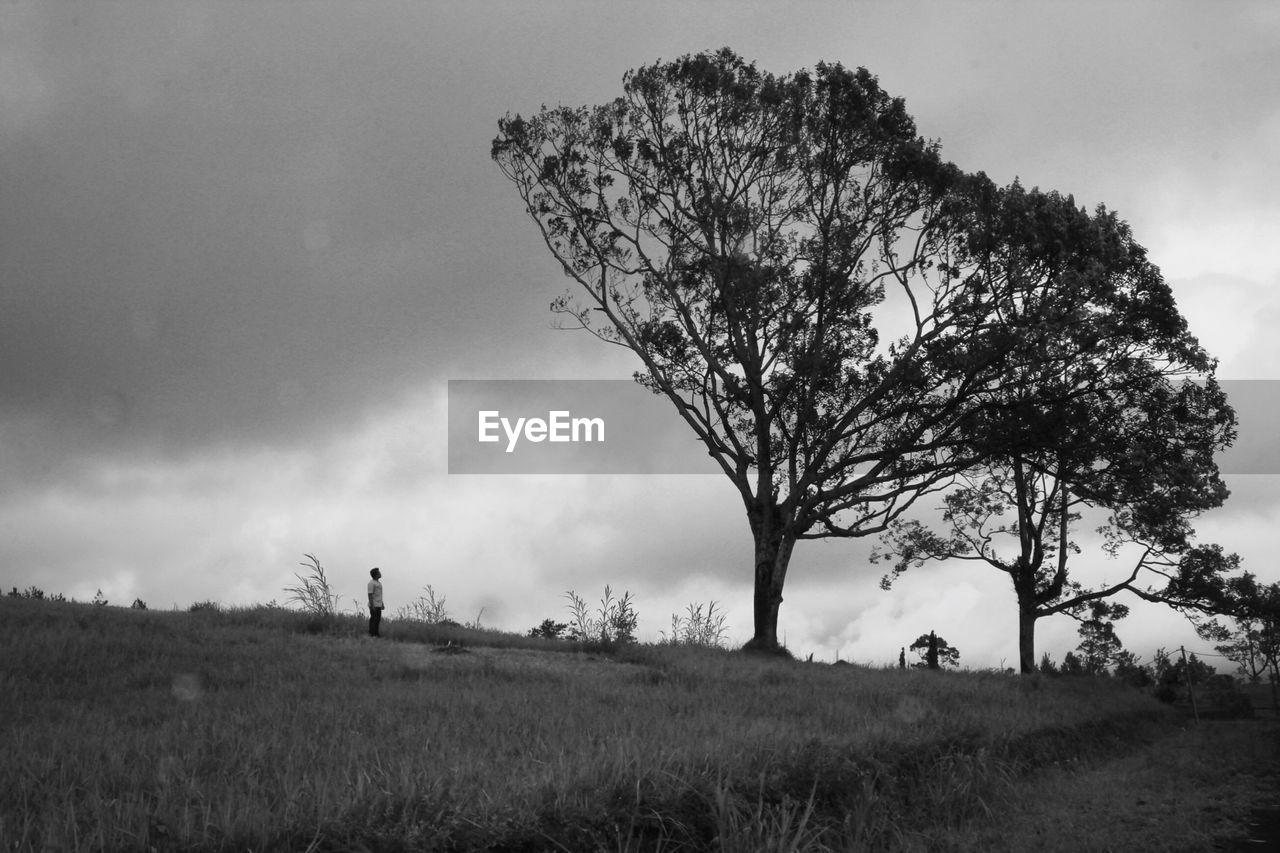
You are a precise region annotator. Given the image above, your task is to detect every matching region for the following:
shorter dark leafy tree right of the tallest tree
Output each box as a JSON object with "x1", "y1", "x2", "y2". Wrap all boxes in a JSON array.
[{"x1": 882, "y1": 177, "x2": 1235, "y2": 672}]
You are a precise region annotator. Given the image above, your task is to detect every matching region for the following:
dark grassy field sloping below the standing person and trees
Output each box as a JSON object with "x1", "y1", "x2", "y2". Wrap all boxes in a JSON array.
[{"x1": 0, "y1": 598, "x2": 1276, "y2": 852}]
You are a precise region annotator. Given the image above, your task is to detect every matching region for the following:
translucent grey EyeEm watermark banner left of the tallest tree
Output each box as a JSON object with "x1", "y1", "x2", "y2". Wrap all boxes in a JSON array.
[{"x1": 449, "y1": 379, "x2": 719, "y2": 474}]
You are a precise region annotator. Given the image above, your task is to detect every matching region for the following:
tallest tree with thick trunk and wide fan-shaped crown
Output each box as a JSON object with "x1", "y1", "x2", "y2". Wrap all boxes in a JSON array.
[{"x1": 493, "y1": 49, "x2": 1039, "y2": 649}]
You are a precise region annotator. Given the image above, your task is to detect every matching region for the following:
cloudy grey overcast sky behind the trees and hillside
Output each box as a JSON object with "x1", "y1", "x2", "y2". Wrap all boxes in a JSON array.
[{"x1": 0, "y1": 0, "x2": 1280, "y2": 666}]
